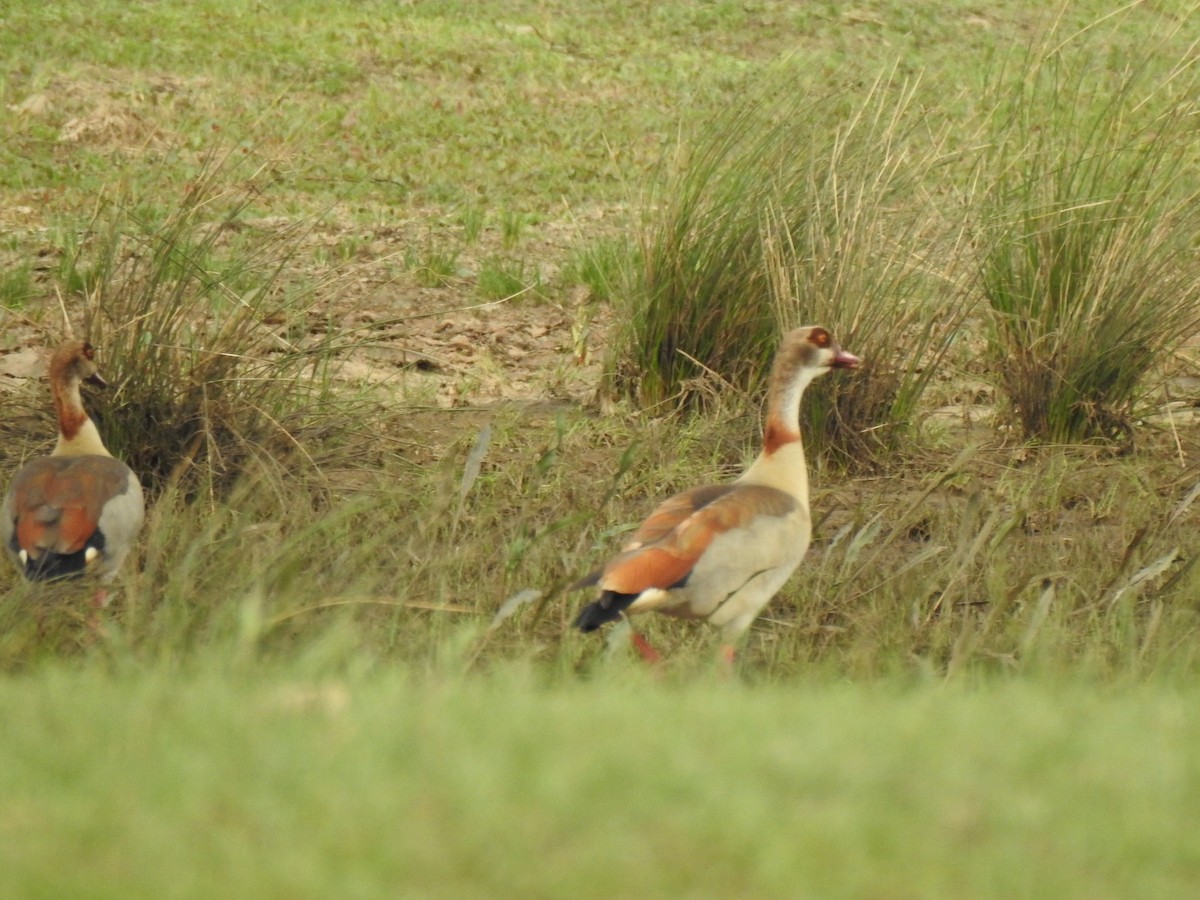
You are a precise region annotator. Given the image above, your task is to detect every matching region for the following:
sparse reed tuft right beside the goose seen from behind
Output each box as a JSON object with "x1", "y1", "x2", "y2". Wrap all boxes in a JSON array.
[{"x1": 45, "y1": 154, "x2": 374, "y2": 493}]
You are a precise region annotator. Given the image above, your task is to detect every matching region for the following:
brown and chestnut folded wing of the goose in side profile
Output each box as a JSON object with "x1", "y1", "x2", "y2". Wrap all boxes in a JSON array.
[{"x1": 599, "y1": 484, "x2": 797, "y2": 595}]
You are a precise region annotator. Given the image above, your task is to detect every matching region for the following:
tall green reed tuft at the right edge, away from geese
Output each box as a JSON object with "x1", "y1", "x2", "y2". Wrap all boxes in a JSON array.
[{"x1": 976, "y1": 32, "x2": 1200, "y2": 442}]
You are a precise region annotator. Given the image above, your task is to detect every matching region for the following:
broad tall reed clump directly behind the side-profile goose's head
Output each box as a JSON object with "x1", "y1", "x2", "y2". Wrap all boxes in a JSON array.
[{"x1": 611, "y1": 67, "x2": 967, "y2": 464}]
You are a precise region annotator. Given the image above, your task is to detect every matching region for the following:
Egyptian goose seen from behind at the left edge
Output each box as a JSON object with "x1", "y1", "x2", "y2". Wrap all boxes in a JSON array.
[{"x1": 0, "y1": 341, "x2": 145, "y2": 595}]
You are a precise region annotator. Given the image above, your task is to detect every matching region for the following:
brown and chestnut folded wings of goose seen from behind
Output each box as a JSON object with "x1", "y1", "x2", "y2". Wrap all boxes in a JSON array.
[{"x1": 12, "y1": 456, "x2": 128, "y2": 558}]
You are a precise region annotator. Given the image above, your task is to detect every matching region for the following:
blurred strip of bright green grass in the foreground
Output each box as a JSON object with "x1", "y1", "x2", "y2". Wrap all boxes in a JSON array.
[{"x1": 0, "y1": 665, "x2": 1200, "y2": 900}]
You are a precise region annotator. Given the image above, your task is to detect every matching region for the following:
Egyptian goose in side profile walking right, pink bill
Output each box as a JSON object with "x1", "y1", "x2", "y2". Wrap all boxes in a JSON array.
[{"x1": 574, "y1": 325, "x2": 859, "y2": 662}]
